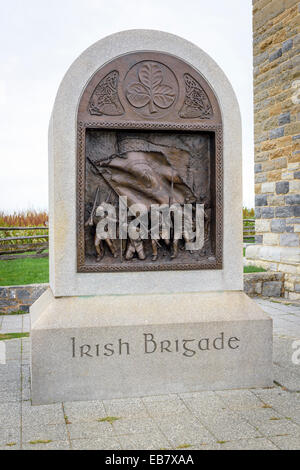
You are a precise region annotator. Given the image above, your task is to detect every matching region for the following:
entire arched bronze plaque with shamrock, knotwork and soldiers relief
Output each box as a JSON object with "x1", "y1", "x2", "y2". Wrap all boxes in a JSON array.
[{"x1": 77, "y1": 52, "x2": 223, "y2": 272}]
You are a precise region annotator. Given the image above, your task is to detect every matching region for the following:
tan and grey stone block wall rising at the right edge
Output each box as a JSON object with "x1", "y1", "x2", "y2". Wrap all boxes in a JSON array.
[{"x1": 246, "y1": 0, "x2": 300, "y2": 300}]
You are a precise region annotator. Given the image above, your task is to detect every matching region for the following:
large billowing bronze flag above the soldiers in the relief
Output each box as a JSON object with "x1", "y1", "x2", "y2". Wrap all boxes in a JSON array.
[{"x1": 97, "y1": 138, "x2": 196, "y2": 210}]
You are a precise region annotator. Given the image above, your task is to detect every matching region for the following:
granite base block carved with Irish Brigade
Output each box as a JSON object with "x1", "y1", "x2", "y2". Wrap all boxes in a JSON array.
[{"x1": 30, "y1": 289, "x2": 272, "y2": 404}]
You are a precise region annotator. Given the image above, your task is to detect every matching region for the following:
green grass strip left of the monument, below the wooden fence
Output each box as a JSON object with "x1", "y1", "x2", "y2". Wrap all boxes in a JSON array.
[{"x1": 0, "y1": 258, "x2": 49, "y2": 286}]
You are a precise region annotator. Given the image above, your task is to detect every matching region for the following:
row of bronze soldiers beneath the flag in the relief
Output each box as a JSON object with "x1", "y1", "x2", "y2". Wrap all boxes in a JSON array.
[{"x1": 86, "y1": 194, "x2": 205, "y2": 262}]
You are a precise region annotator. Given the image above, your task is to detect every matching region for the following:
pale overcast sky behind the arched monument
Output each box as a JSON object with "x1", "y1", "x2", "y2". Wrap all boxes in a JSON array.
[{"x1": 0, "y1": 0, "x2": 254, "y2": 212}]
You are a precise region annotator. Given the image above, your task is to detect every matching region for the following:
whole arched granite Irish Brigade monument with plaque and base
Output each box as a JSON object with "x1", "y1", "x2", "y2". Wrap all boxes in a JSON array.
[{"x1": 31, "y1": 30, "x2": 272, "y2": 404}]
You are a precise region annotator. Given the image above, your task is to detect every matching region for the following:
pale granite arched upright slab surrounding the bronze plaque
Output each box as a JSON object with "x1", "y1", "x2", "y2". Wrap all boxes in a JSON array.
[{"x1": 49, "y1": 30, "x2": 243, "y2": 296}]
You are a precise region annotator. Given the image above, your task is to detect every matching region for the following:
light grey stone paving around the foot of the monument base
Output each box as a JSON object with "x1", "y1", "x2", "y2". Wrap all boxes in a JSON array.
[{"x1": 0, "y1": 298, "x2": 300, "y2": 450}]
